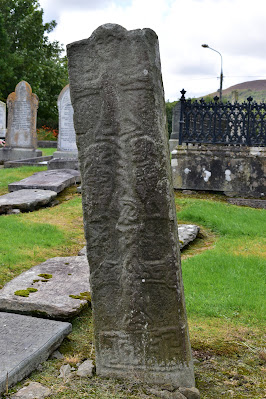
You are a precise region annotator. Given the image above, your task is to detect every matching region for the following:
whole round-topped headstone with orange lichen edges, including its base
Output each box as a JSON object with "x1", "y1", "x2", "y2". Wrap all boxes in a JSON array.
[{"x1": 0, "y1": 80, "x2": 42, "y2": 161}]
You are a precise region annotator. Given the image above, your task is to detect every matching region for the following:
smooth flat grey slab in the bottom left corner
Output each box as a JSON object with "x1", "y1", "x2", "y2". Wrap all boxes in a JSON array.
[{"x1": 0, "y1": 312, "x2": 72, "y2": 394}]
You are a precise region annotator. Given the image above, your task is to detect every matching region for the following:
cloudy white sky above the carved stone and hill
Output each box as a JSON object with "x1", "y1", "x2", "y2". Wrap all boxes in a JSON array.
[{"x1": 39, "y1": 0, "x2": 266, "y2": 101}]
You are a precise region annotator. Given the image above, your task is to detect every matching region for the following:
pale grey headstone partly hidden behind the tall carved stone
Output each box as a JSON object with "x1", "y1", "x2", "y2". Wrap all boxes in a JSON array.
[{"x1": 53, "y1": 85, "x2": 78, "y2": 158}]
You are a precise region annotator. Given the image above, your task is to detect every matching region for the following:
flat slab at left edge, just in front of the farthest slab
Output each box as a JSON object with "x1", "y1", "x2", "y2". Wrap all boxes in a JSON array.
[{"x1": 0, "y1": 190, "x2": 57, "y2": 214}]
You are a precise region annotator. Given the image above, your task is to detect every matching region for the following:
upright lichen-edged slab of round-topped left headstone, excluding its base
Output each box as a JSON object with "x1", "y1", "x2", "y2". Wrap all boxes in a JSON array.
[{"x1": 6, "y1": 80, "x2": 39, "y2": 150}]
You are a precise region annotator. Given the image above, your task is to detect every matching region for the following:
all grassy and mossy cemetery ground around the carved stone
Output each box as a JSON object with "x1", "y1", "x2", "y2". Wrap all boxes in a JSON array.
[{"x1": 0, "y1": 167, "x2": 266, "y2": 399}]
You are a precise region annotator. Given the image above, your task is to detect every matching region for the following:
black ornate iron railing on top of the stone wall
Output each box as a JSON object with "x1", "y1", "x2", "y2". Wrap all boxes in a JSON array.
[{"x1": 179, "y1": 89, "x2": 266, "y2": 147}]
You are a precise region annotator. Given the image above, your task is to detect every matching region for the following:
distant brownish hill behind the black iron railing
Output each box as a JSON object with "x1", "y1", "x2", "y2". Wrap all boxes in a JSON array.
[{"x1": 204, "y1": 80, "x2": 266, "y2": 103}]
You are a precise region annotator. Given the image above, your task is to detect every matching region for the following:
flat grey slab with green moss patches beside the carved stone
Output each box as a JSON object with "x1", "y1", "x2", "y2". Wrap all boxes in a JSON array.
[{"x1": 0, "y1": 256, "x2": 90, "y2": 319}]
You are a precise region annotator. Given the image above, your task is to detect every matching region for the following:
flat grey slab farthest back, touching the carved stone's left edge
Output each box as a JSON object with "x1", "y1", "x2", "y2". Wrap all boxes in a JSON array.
[{"x1": 8, "y1": 169, "x2": 80, "y2": 193}]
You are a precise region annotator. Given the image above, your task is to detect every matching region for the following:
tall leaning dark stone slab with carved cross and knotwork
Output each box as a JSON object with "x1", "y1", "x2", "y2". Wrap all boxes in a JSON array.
[{"x1": 67, "y1": 24, "x2": 195, "y2": 387}]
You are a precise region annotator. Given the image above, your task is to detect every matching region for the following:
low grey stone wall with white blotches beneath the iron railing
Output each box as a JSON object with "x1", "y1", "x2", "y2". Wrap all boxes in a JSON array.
[{"x1": 171, "y1": 145, "x2": 266, "y2": 198}]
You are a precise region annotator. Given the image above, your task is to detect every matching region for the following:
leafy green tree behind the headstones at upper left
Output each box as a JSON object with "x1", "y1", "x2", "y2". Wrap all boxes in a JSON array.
[{"x1": 0, "y1": 0, "x2": 68, "y2": 125}]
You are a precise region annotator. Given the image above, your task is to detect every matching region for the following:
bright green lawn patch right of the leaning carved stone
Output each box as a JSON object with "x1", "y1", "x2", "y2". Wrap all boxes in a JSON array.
[{"x1": 176, "y1": 199, "x2": 266, "y2": 324}]
